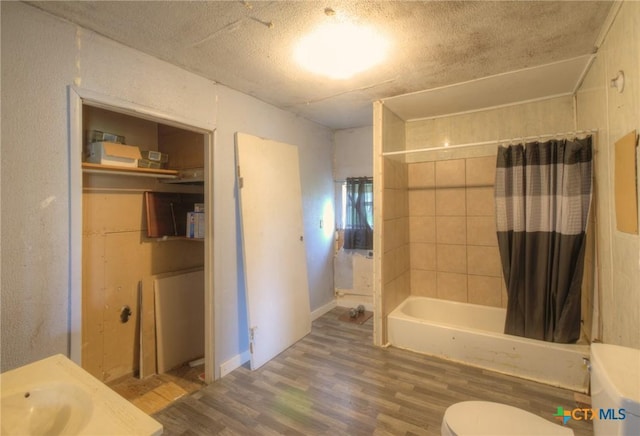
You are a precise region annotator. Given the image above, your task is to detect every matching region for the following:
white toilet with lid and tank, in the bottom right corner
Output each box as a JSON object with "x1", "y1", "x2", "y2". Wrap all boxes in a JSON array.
[{"x1": 440, "y1": 343, "x2": 640, "y2": 436}]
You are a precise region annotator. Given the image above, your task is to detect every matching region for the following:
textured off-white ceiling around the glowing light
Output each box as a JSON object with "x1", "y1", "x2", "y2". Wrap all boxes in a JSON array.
[{"x1": 27, "y1": 0, "x2": 612, "y2": 129}]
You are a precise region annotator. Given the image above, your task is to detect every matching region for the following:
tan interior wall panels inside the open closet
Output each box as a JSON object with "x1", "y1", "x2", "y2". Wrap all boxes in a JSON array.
[{"x1": 82, "y1": 106, "x2": 204, "y2": 382}]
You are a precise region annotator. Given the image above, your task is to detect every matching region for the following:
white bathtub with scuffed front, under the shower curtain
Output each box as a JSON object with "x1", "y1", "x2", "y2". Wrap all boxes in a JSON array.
[{"x1": 387, "y1": 296, "x2": 589, "y2": 393}]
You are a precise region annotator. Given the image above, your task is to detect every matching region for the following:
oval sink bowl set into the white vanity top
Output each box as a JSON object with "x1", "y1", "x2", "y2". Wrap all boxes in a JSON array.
[{"x1": 0, "y1": 382, "x2": 93, "y2": 436}]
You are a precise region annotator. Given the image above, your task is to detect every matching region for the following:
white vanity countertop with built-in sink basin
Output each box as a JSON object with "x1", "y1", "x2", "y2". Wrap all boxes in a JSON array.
[{"x1": 0, "y1": 355, "x2": 162, "y2": 436}]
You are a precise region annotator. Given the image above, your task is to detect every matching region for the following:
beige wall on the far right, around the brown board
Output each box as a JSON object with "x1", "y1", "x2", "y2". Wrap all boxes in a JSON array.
[{"x1": 577, "y1": 2, "x2": 640, "y2": 348}]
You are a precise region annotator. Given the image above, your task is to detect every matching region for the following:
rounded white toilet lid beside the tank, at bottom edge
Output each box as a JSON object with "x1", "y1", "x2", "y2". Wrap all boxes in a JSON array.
[{"x1": 443, "y1": 401, "x2": 573, "y2": 436}]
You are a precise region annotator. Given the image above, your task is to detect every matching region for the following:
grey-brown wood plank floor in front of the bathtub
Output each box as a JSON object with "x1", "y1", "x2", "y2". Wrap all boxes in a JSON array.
[{"x1": 154, "y1": 308, "x2": 593, "y2": 436}]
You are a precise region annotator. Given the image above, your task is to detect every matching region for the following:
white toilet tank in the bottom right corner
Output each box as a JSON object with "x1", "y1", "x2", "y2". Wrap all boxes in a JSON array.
[{"x1": 591, "y1": 343, "x2": 640, "y2": 436}]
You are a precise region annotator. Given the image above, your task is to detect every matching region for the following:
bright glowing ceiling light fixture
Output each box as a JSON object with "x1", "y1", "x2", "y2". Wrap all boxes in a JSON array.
[{"x1": 294, "y1": 16, "x2": 389, "y2": 79}]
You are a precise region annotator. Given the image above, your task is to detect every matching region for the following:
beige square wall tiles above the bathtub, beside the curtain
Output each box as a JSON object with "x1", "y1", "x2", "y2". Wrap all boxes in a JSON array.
[{"x1": 384, "y1": 156, "x2": 507, "y2": 307}]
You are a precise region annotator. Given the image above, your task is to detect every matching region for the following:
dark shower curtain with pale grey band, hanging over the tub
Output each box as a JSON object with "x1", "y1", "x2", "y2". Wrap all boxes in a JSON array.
[{"x1": 495, "y1": 136, "x2": 592, "y2": 343}]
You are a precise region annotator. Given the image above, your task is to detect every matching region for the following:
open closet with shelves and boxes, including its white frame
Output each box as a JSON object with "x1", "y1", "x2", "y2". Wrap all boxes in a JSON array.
[{"x1": 69, "y1": 88, "x2": 214, "y2": 413}]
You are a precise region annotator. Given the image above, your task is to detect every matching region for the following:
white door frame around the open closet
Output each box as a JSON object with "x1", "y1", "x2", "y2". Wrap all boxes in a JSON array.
[{"x1": 67, "y1": 86, "x2": 216, "y2": 383}]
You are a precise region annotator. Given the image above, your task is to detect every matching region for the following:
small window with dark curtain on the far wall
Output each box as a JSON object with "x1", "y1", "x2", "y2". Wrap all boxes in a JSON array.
[{"x1": 342, "y1": 177, "x2": 373, "y2": 250}]
